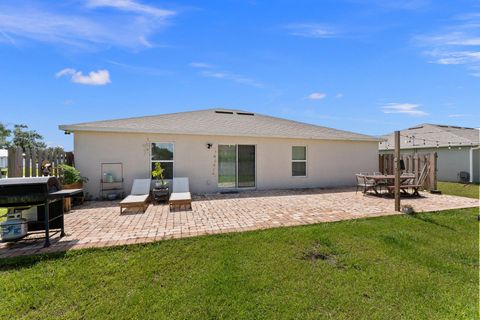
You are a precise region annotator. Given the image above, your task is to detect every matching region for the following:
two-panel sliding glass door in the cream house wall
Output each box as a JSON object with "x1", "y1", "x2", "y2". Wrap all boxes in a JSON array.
[{"x1": 218, "y1": 145, "x2": 255, "y2": 188}]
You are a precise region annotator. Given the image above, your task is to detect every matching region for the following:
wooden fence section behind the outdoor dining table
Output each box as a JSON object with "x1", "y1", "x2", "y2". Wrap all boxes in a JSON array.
[{"x1": 378, "y1": 152, "x2": 437, "y2": 190}]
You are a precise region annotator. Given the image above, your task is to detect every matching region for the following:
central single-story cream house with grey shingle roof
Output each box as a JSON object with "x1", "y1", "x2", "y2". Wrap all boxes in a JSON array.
[{"x1": 59, "y1": 109, "x2": 380, "y2": 196}]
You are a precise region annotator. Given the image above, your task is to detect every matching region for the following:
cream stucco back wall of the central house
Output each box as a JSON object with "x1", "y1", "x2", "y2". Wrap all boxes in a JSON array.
[{"x1": 74, "y1": 132, "x2": 378, "y2": 198}]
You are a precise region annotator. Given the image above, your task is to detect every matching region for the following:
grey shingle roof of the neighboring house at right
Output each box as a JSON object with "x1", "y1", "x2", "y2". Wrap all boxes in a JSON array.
[{"x1": 379, "y1": 123, "x2": 480, "y2": 150}]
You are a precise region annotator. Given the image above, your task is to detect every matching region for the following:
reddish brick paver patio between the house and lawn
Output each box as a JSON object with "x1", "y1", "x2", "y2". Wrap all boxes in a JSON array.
[{"x1": 0, "y1": 189, "x2": 479, "y2": 258}]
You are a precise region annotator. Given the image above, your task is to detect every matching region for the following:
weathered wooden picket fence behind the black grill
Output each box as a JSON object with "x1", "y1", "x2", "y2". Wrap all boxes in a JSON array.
[{"x1": 8, "y1": 147, "x2": 73, "y2": 178}]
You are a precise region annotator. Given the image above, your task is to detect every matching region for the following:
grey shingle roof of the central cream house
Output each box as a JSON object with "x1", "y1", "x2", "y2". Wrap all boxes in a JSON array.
[{"x1": 59, "y1": 109, "x2": 379, "y2": 141}]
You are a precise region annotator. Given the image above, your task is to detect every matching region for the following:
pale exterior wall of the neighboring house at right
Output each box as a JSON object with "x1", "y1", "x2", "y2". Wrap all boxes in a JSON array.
[{"x1": 380, "y1": 147, "x2": 479, "y2": 182}]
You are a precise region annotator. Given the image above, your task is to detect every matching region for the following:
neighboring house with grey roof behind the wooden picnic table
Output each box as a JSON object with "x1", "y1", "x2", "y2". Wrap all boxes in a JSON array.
[{"x1": 379, "y1": 124, "x2": 480, "y2": 182}]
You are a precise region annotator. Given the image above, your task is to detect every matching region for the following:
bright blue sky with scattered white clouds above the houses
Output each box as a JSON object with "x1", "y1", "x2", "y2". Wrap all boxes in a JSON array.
[{"x1": 0, "y1": 0, "x2": 480, "y2": 149}]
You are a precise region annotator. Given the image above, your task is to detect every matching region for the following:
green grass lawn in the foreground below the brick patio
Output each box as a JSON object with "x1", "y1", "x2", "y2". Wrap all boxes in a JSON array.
[{"x1": 0, "y1": 209, "x2": 479, "y2": 319}]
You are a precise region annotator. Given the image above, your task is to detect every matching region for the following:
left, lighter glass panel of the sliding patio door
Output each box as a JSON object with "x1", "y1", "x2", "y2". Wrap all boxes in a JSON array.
[{"x1": 218, "y1": 145, "x2": 237, "y2": 188}]
